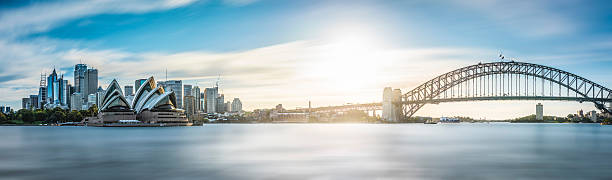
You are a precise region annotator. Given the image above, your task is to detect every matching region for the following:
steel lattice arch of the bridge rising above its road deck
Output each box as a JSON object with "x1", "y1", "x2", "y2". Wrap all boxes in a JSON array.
[{"x1": 402, "y1": 62, "x2": 612, "y2": 118}]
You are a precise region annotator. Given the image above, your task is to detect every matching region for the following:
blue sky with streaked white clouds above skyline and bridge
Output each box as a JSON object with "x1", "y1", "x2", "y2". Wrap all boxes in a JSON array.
[{"x1": 0, "y1": 0, "x2": 612, "y2": 119}]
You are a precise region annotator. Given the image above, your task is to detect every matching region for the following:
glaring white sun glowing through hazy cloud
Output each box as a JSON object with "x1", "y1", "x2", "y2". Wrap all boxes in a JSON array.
[{"x1": 315, "y1": 27, "x2": 390, "y2": 91}]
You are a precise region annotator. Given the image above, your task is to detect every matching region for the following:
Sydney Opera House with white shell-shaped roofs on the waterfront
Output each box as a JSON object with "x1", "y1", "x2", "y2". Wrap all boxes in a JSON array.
[{"x1": 88, "y1": 77, "x2": 191, "y2": 126}]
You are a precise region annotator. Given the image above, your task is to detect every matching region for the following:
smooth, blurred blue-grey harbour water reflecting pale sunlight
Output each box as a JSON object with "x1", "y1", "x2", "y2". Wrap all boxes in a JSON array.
[{"x1": 0, "y1": 123, "x2": 612, "y2": 180}]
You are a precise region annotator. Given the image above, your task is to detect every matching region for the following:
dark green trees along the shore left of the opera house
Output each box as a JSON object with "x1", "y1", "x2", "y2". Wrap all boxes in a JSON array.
[{"x1": 0, "y1": 104, "x2": 98, "y2": 124}]
